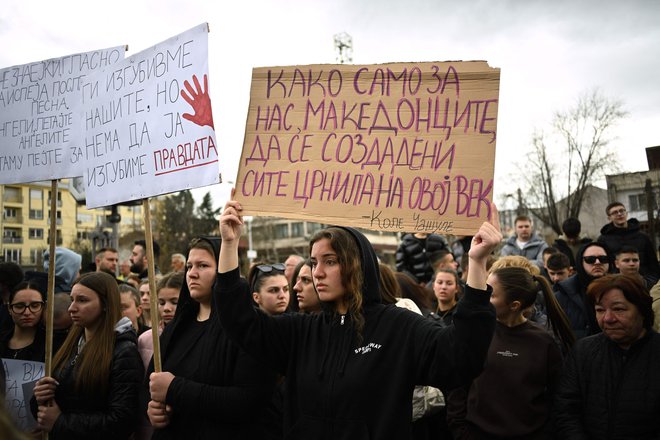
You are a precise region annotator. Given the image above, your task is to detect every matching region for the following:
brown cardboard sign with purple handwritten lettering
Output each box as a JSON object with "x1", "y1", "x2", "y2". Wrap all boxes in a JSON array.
[{"x1": 236, "y1": 61, "x2": 500, "y2": 234}]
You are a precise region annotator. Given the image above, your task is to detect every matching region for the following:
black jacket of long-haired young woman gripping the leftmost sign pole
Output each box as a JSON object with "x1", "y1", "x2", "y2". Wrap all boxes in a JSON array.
[{"x1": 30, "y1": 319, "x2": 144, "y2": 440}]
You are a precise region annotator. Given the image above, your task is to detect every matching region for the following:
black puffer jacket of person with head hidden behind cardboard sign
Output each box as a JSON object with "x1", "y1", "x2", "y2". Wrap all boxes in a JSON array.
[{"x1": 396, "y1": 234, "x2": 448, "y2": 283}]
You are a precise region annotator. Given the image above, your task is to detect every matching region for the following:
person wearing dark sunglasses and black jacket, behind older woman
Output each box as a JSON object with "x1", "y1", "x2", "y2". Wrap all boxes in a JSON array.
[{"x1": 554, "y1": 242, "x2": 614, "y2": 339}]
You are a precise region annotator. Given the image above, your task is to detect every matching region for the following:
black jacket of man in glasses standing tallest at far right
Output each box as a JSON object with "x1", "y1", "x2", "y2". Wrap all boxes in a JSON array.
[{"x1": 597, "y1": 218, "x2": 660, "y2": 279}]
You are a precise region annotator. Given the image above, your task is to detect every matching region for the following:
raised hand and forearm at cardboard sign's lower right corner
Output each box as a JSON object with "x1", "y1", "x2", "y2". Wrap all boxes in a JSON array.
[{"x1": 467, "y1": 205, "x2": 502, "y2": 290}]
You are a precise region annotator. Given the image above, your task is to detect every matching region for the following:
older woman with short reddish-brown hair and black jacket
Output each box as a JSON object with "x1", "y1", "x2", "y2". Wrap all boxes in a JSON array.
[{"x1": 555, "y1": 275, "x2": 660, "y2": 439}]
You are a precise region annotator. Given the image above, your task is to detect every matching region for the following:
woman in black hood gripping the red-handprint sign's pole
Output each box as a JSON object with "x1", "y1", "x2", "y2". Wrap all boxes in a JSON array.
[{"x1": 147, "y1": 237, "x2": 275, "y2": 439}]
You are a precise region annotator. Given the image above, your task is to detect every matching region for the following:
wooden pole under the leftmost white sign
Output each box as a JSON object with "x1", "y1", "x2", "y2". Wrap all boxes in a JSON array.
[{"x1": 42, "y1": 179, "x2": 57, "y2": 440}]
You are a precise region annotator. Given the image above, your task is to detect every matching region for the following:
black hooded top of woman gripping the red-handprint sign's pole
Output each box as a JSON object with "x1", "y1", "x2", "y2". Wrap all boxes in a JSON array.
[{"x1": 143, "y1": 237, "x2": 275, "y2": 439}]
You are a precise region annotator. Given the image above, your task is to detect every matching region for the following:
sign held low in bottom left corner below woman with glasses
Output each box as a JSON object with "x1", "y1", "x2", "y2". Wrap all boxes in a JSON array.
[{"x1": 2, "y1": 358, "x2": 44, "y2": 431}]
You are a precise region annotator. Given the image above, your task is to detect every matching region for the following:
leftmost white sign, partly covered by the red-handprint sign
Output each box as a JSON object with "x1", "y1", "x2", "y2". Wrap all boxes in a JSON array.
[{"x1": 0, "y1": 47, "x2": 125, "y2": 184}]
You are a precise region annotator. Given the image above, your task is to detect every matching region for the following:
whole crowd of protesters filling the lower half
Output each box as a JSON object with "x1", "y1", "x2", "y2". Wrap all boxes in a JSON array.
[{"x1": 0, "y1": 200, "x2": 660, "y2": 440}]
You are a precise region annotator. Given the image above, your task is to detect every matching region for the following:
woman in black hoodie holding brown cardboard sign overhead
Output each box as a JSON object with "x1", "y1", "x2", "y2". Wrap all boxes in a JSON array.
[{"x1": 217, "y1": 201, "x2": 502, "y2": 440}]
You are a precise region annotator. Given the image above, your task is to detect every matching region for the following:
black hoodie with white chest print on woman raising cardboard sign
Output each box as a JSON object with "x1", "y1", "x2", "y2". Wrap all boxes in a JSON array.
[{"x1": 217, "y1": 228, "x2": 495, "y2": 440}]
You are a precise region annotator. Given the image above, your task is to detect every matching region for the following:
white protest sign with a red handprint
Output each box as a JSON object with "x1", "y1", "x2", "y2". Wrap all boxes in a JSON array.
[{"x1": 80, "y1": 24, "x2": 220, "y2": 208}]
